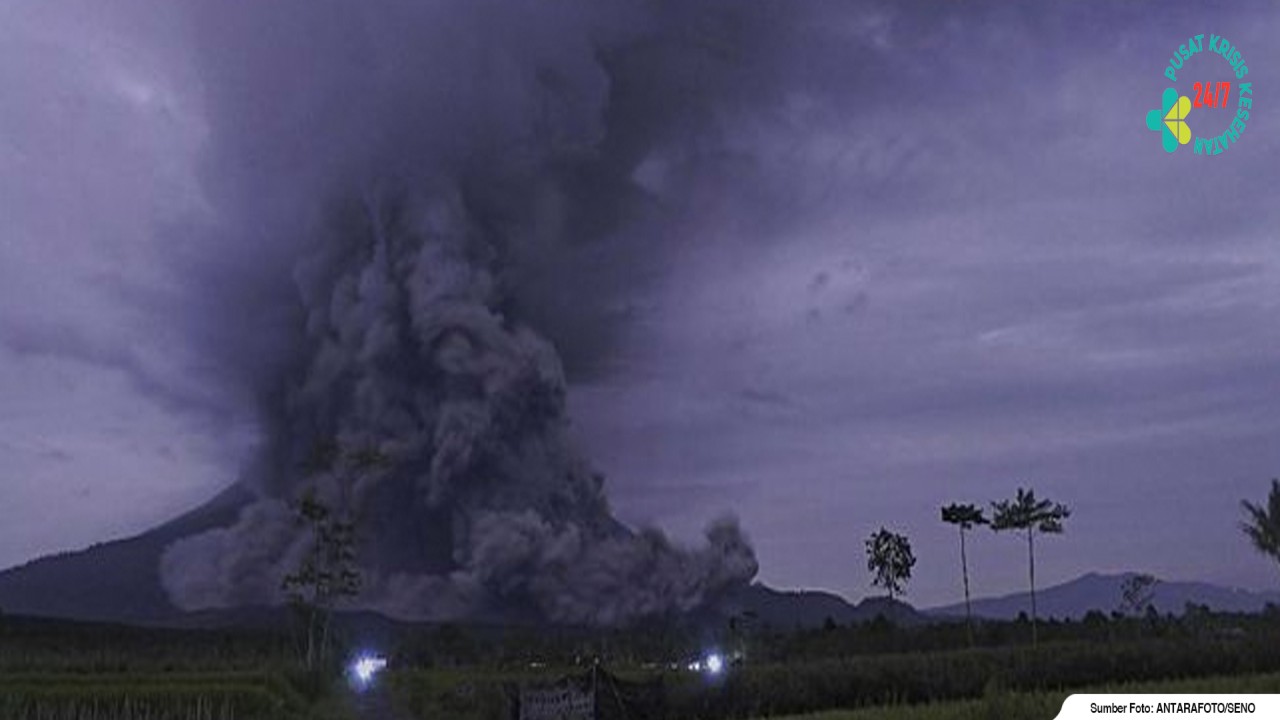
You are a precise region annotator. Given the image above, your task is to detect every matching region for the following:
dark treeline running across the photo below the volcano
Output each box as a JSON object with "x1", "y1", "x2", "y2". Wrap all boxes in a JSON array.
[{"x1": 10, "y1": 606, "x2": 1280, "y2": 673}]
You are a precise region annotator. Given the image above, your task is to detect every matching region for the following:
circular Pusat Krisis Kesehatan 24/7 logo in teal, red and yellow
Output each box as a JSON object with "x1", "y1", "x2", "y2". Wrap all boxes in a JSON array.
[{"x1": 1147, "y1": 35, "x2": 1253, "y2": 155}]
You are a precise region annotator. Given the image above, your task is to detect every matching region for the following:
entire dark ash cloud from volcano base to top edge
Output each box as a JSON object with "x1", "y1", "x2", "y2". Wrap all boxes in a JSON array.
[{"x1": 161, "y1": 3, "x2": 788, "y2": 624}]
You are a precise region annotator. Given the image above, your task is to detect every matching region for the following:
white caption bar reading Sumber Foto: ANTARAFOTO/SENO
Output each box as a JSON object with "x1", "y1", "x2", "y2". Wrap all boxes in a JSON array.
[{"x1": 1055, "y1": 693, "x2": 1280, "y2": 720}]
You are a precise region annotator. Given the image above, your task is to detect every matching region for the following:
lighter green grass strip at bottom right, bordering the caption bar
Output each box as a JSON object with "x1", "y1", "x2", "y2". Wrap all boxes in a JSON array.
[{"x1": 771, "y1": 673, "x2": 1280, "y2": 720}]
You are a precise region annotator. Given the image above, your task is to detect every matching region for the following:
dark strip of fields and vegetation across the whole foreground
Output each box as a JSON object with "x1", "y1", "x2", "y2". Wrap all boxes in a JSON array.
[{"x1": 0, "y1": 607, "x2": 1280, "y2": 720}]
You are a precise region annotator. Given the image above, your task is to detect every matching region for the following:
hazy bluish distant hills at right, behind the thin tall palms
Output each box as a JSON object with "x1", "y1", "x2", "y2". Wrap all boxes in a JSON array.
[{"x1": 925, "y1": 573, "x2": 1280, "y2": 620}]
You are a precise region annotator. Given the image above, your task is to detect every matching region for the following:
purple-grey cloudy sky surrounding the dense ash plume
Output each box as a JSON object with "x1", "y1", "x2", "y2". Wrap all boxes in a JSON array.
[{"x1": 0, "y1": 1, "x2": 1280, "y2": 605}]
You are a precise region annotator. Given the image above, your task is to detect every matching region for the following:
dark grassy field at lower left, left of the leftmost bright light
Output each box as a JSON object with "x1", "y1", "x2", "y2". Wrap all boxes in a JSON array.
[{"x1": 0, "y1": 615, "x2": 342, "y2": 720}]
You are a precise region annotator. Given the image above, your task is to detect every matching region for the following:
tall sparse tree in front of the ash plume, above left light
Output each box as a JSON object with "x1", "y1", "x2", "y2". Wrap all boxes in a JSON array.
[{"x1": 280, "y1": 441, "x2": 387, "y2": 670}]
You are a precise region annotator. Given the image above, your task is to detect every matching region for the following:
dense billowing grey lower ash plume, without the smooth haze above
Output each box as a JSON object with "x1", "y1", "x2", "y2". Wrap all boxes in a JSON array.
[{"x1": 161, "y1": 183, "x2": 756, "y2": 624}]
